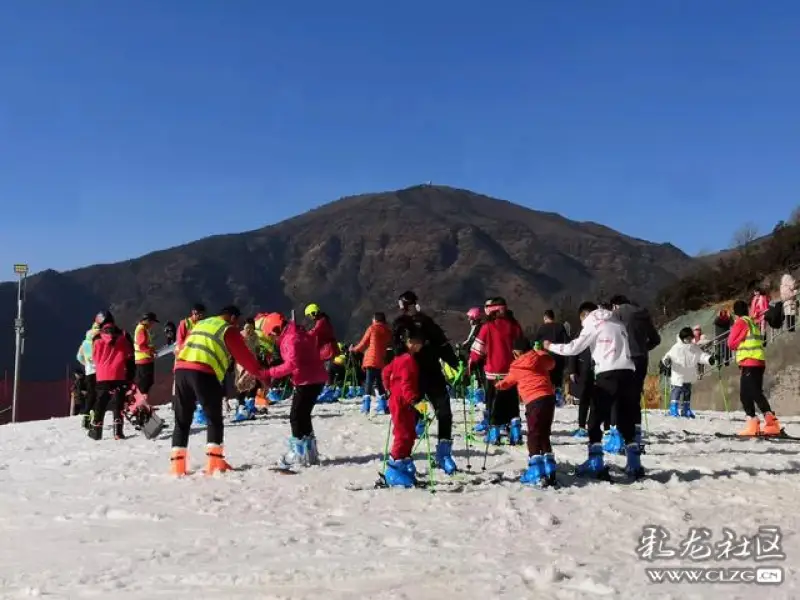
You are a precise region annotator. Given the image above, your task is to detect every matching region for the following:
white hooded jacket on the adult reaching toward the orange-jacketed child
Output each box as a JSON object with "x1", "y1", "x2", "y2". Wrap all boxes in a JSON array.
[{"x1": 548, "y1": 308, "x2": 636, "y2": 375}]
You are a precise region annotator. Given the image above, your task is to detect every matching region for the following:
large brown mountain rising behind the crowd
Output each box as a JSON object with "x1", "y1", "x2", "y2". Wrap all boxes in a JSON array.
[{"x1": 0, "y1": 186, "x2": 693, "y2": 379}]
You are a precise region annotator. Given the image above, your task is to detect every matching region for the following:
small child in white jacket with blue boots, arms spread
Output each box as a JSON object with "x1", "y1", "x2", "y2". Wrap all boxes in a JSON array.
[{"x1": 661, "y1": 327, "x2": 716, "y2": 419}]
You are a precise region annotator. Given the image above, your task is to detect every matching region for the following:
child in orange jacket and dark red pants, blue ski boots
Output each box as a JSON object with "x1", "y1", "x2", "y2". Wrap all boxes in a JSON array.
[{"x1": 495, "y1": 337, "x2": 556, "y2": 486}]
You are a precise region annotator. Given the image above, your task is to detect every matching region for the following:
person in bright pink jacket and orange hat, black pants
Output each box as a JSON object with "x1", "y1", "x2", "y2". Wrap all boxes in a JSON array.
[{"x1": 269, "y1": 318, "x2": 328, "y2": 469}]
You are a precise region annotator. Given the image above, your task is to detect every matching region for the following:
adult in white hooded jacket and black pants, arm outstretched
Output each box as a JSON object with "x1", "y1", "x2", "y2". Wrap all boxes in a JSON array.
[{"x1": 543, "y1": 302, "x2": 644, "y2": 477}]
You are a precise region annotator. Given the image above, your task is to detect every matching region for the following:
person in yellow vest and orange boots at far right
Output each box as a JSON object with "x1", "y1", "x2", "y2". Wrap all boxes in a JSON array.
[{"x1": 728, "y1": 300, "x2": 781, "y2": 436}]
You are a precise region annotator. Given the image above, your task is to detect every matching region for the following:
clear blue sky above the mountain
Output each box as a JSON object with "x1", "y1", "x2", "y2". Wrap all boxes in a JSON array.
[{"x1": 0, "y1": 0, "x2": 800, "y2": 280}]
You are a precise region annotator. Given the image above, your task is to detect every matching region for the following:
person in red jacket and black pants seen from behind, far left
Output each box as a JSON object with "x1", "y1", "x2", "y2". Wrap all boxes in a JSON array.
[{"x1": 88, "y1": 311, "x2": 134, "y2": 441}]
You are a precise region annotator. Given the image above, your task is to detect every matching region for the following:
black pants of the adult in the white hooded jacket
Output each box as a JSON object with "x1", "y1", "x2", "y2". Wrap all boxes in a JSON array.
[{"x1": 589, "y1": 370, "x2": 641, "y2": 444}]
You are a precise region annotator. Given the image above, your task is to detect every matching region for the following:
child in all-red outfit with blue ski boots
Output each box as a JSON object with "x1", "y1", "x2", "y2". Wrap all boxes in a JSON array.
[{"x1": 382, "y1": 330, "x2": 425, "y2": 488}]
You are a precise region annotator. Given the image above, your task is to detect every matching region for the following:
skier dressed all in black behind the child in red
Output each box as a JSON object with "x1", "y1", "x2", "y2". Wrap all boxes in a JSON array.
[{"x1": 392, "y1": 291, "x2": 458, "y2": 475}]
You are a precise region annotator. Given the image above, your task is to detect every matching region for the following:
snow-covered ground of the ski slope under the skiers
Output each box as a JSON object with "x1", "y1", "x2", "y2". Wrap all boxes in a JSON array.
[{"x1": 0, "y1": 404, "x2": 800, "y2": 600}]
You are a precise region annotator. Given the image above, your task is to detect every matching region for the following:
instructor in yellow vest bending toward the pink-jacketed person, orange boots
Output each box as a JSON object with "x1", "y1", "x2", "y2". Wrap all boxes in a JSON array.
[{"x1": 170, "y1": 306, "x2": 270, "y2": 476}]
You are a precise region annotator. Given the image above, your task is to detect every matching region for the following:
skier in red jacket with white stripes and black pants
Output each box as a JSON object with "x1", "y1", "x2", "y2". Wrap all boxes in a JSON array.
[{"x1": 469, "y1": 297, "x2": 522, "y2": 445}]
